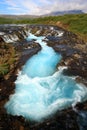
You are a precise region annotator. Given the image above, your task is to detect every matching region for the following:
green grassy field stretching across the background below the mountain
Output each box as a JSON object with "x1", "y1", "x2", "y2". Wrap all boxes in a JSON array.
[{"x1": 0, "y1": 14, "x2": 87, "y2": 41}]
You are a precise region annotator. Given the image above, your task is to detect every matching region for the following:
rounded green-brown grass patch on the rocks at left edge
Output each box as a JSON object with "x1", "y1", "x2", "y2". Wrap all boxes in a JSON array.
[{"x1": 0, "y1": 42, "x2": 16, "y2": 77}]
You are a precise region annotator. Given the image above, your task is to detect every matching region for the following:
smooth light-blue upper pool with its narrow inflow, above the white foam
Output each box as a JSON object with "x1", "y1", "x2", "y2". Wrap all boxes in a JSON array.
[{"x1": 22, "y1": 34, "x2": 62, "y2": 77}]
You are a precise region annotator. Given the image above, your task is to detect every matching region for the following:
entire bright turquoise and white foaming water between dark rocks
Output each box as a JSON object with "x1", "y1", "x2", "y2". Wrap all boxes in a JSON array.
[{"x1": 5, "y1": 33, "x2": 87, "y2": 121}]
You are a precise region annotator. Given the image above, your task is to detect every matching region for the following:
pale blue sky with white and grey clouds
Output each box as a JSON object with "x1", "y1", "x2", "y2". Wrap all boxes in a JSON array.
[{"x1": 0, "y1": 0, "x2": 87, "y2": 15}]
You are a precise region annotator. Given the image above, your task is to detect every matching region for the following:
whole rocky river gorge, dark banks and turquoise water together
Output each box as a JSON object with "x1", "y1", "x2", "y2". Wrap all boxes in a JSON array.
[{"x1": 0, "y1": 25, "x2": 87, "y2": 130}]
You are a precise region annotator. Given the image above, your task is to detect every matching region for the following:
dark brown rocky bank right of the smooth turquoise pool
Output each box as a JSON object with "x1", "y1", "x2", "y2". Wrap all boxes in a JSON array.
[{"x1": 48, "y1": 29, "x2": 87, "y2": 80}]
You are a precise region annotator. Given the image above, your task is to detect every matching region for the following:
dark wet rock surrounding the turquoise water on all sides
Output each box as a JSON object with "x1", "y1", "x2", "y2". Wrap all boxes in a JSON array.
[{"x1": 0, "y1": 25, "x2": 87, "y2": 130}]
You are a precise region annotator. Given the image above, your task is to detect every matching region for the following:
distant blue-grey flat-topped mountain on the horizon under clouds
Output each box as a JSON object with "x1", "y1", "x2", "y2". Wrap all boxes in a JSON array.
[{"x1": 44, "y1": 10, "x2": 84, "y2": 16}]
